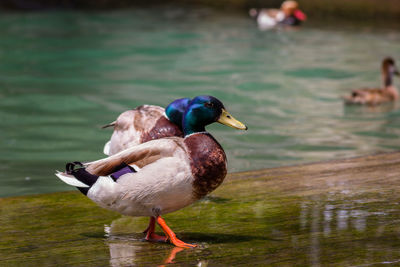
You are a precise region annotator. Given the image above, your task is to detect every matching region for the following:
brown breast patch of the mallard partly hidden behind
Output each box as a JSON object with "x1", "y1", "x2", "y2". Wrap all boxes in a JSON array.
[{"x1": 141, "y1": 116, "x2": 183, "y2": 143}]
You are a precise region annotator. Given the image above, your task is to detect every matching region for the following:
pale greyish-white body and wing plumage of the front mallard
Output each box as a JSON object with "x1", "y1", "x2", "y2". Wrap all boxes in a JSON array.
[{"x1": 57, "y1": 137, "x2": 196, "y2": 219}]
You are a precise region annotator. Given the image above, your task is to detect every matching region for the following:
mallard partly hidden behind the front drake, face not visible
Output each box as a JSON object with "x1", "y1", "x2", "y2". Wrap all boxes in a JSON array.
[{"x1": 103, "y1": 98, "x2": 190, "y2": 156}]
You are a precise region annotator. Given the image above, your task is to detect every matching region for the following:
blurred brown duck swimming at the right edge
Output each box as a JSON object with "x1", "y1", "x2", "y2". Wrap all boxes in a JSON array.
[{"x1": 343, "y1": 57, "x2": 400, "y2": 106}]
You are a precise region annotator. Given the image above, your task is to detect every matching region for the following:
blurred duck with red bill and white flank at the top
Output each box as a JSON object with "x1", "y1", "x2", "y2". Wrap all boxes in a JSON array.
[{"x1": 249, "y1": 1, "x2": 307, "y2": 29}]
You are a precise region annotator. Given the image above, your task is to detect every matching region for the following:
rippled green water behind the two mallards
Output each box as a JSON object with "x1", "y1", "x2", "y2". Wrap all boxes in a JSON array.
[{"x1": 0, "y1": 7, "x2": 400, "y2": 197}]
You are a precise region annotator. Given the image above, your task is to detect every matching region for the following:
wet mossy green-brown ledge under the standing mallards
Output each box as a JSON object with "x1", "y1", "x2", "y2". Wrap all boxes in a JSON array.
[{"x1": 0, "y1": 153, "x2": 400, "y2": 266}]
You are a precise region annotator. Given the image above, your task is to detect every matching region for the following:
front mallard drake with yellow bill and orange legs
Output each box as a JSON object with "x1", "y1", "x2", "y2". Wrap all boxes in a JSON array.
[{"x1": 56, "y1": 95, "x2": 247, "y2": 248}]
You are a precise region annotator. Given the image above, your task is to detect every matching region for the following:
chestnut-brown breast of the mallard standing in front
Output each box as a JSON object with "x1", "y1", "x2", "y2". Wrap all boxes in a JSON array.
[{"x1": 184, "y1": 133, "x2": 227, "y2": 199}]
